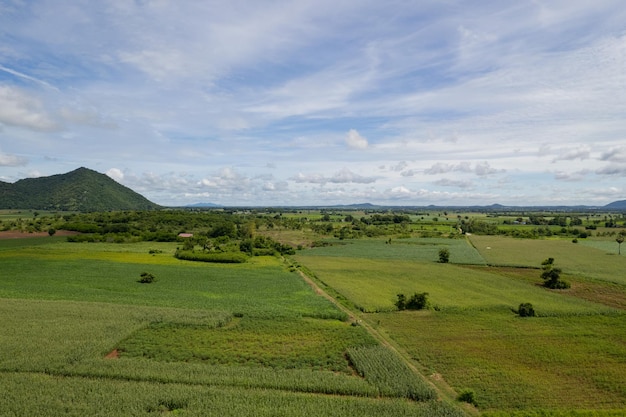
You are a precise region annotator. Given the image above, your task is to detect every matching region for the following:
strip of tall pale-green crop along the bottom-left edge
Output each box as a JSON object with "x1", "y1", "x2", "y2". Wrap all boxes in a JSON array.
[{"x1": 0, "y1": 373, "x2": 463, "y2": 417}]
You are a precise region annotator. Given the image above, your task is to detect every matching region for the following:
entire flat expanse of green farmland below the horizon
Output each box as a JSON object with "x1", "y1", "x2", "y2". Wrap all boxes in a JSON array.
[{"x1": 0, "y1": 211, "x2": 626, "y2": 417}]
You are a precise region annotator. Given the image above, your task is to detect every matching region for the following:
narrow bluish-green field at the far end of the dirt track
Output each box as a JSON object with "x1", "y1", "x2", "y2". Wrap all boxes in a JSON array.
[{"x1": 306, "y1": 238, "x2": 485, "y2": 265}]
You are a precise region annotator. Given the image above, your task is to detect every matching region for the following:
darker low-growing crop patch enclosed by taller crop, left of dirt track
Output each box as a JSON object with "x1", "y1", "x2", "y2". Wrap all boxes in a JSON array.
[{"x1": 117, "y1": 316, "x2": 376, "y2": 374}]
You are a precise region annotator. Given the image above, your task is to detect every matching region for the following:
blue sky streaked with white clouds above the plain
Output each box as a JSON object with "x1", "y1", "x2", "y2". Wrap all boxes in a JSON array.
[{"x1": 0, "y1": 0, "x2": 626, "y2": 206}]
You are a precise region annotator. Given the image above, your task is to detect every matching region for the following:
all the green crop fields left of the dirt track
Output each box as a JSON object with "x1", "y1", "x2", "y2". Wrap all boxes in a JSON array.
[{"x1": 0, "y1": 237, "x2": 462, "y2": 416}]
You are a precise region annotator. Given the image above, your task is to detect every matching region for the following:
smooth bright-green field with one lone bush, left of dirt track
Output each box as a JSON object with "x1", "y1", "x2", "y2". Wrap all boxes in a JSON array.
[{"x1": 0, "y1": 239, "x2": 343, "y2": 318}]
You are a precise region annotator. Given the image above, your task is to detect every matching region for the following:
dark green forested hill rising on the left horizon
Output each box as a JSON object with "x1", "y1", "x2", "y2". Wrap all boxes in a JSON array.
[{"x1": 0, "y1": 168, "x2": 159, "y2": 211}]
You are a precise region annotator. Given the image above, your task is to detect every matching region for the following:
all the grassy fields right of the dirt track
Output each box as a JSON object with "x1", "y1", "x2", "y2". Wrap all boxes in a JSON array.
[{"x1": 295, "y1": 236, "x2": 626, "y2": 416}]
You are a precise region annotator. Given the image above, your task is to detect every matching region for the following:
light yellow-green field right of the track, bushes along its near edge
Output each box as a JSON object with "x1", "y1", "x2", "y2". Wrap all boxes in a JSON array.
[{"x1": 295, "y1": 252, "x2": 615, "y2": 316}]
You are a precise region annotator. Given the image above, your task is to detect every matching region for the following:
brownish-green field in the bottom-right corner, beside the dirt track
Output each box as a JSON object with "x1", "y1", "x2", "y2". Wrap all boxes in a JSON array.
[{"x1": 376, "y1": 311, "x2": 626, "y2": 416}]
